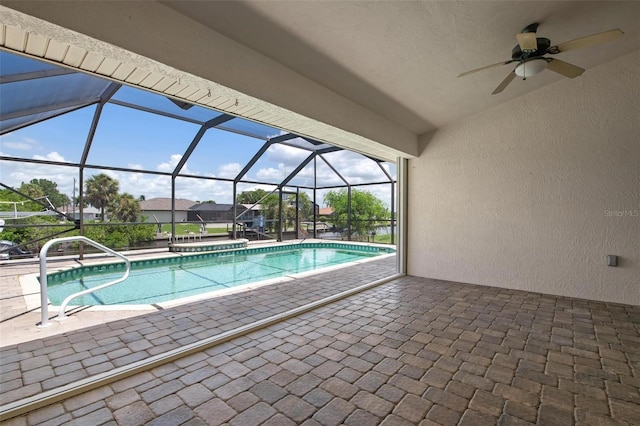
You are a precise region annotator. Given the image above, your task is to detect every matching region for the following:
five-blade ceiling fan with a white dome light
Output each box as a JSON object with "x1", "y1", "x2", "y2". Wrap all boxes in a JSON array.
[{"x1": 458, "y1": 23, "x2": 624, "y2": 95}]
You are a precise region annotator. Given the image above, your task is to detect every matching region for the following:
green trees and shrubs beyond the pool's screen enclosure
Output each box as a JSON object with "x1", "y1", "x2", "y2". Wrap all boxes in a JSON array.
[{"x1": 0, "y1": 173, "x2": 390, "y2": 248}]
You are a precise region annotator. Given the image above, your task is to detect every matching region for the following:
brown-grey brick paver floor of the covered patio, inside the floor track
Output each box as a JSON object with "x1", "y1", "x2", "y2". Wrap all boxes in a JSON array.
[{"x1": 3, "y1": 264, "x2": 640, "y2": 426}]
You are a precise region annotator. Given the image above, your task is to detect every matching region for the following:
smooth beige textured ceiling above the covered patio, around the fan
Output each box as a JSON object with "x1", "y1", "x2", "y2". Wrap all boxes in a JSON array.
[{"x1": 163, "y1": 1, "x2": 640, "y2": 134}]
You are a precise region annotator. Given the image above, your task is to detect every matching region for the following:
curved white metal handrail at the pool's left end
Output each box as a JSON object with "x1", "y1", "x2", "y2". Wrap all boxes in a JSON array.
[{"x1": 38, "y1": 236, "x2": 131, "y2": 327}]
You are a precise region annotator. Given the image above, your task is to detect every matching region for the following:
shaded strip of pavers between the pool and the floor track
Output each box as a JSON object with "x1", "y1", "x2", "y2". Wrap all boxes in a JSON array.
[{"x1": 0, "y1": 256, "x2": 395, "y2": 404}]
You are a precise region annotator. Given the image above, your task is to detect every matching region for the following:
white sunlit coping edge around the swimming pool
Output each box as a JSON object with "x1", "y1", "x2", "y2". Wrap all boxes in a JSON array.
[{"x1": 19, "y1": 238, "x2": 396, "y2": 312}]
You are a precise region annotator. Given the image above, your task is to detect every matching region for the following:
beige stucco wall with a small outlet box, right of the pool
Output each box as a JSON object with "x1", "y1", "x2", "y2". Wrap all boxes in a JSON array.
[{"x1": 408, "y1": 51, "x2": 640, "y2": 305}]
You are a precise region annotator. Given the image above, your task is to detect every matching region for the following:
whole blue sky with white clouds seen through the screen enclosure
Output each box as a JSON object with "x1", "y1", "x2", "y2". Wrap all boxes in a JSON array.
[{"x1": 0, "y1": 53, "x2": 395, "y2": 206}]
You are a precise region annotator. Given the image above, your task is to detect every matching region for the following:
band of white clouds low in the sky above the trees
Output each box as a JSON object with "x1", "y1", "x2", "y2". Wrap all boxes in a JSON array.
[{"x1": 0, "y1": 147, "x2": 390, "y2": 205}]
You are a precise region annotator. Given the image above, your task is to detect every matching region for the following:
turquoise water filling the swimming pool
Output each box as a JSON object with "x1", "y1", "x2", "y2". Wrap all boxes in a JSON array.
[{"x1": 47, "y1": 243, "x2": 395, "y2": 305}]
